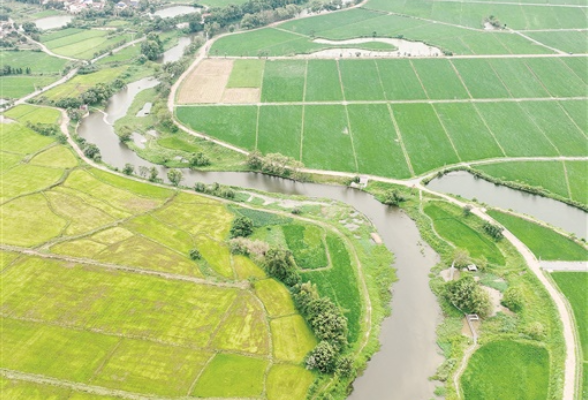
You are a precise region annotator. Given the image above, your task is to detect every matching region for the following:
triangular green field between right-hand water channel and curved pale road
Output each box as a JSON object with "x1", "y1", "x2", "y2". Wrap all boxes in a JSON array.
[{"x1": 489, "y1": 211, "x2": 588, "y2": 261}]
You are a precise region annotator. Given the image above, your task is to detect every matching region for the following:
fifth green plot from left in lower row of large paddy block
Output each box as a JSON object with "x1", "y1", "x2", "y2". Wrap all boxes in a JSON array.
[{"x1": 392, "y1": 104, "x2": 459, "y2": 175}]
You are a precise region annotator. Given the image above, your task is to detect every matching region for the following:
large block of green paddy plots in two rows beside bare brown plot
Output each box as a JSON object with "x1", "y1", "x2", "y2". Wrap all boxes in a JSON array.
[{"x1": 176, "y1": 58, "x2": 588, "y2": 179}]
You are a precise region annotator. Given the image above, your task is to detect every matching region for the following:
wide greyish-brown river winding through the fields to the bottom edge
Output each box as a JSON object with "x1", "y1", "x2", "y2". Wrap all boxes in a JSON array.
[{"x1": 78, "y1": 80, "x2": 442, "y2": 400}]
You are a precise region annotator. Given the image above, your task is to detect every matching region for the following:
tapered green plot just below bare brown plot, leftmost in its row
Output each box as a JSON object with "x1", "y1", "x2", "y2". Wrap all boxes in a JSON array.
[{"x1": 176, "y1": 106, "x2": 257, "y2": 150}]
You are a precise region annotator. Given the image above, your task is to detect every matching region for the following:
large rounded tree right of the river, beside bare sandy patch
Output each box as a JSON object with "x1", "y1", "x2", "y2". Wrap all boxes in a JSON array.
[{"x1": 445, "y1": 274, "x2": 491, "y2": 317}]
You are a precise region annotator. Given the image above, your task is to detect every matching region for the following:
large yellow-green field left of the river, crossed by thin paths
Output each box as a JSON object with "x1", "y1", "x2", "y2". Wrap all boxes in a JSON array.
[{"x1": 0, "y1": 107, "x2": 316, "y2": 400}]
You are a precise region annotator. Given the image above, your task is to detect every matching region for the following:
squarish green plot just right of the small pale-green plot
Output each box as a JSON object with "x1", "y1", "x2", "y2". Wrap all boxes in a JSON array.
[{"x1": 261, "y1": 60, "x2": 306, "y2": 103}]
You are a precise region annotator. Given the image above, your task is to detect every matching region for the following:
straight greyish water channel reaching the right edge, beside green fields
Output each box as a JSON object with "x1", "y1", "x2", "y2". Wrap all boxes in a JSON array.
[{"x1": 428, "y1": 171, "x2": 588, "y2": 238}]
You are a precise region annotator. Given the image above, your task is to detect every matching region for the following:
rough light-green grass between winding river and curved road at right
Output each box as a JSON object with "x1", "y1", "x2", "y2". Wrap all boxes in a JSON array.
[{"x1": 367, "y1": 183, "x2": 566, "y2": 400}]
